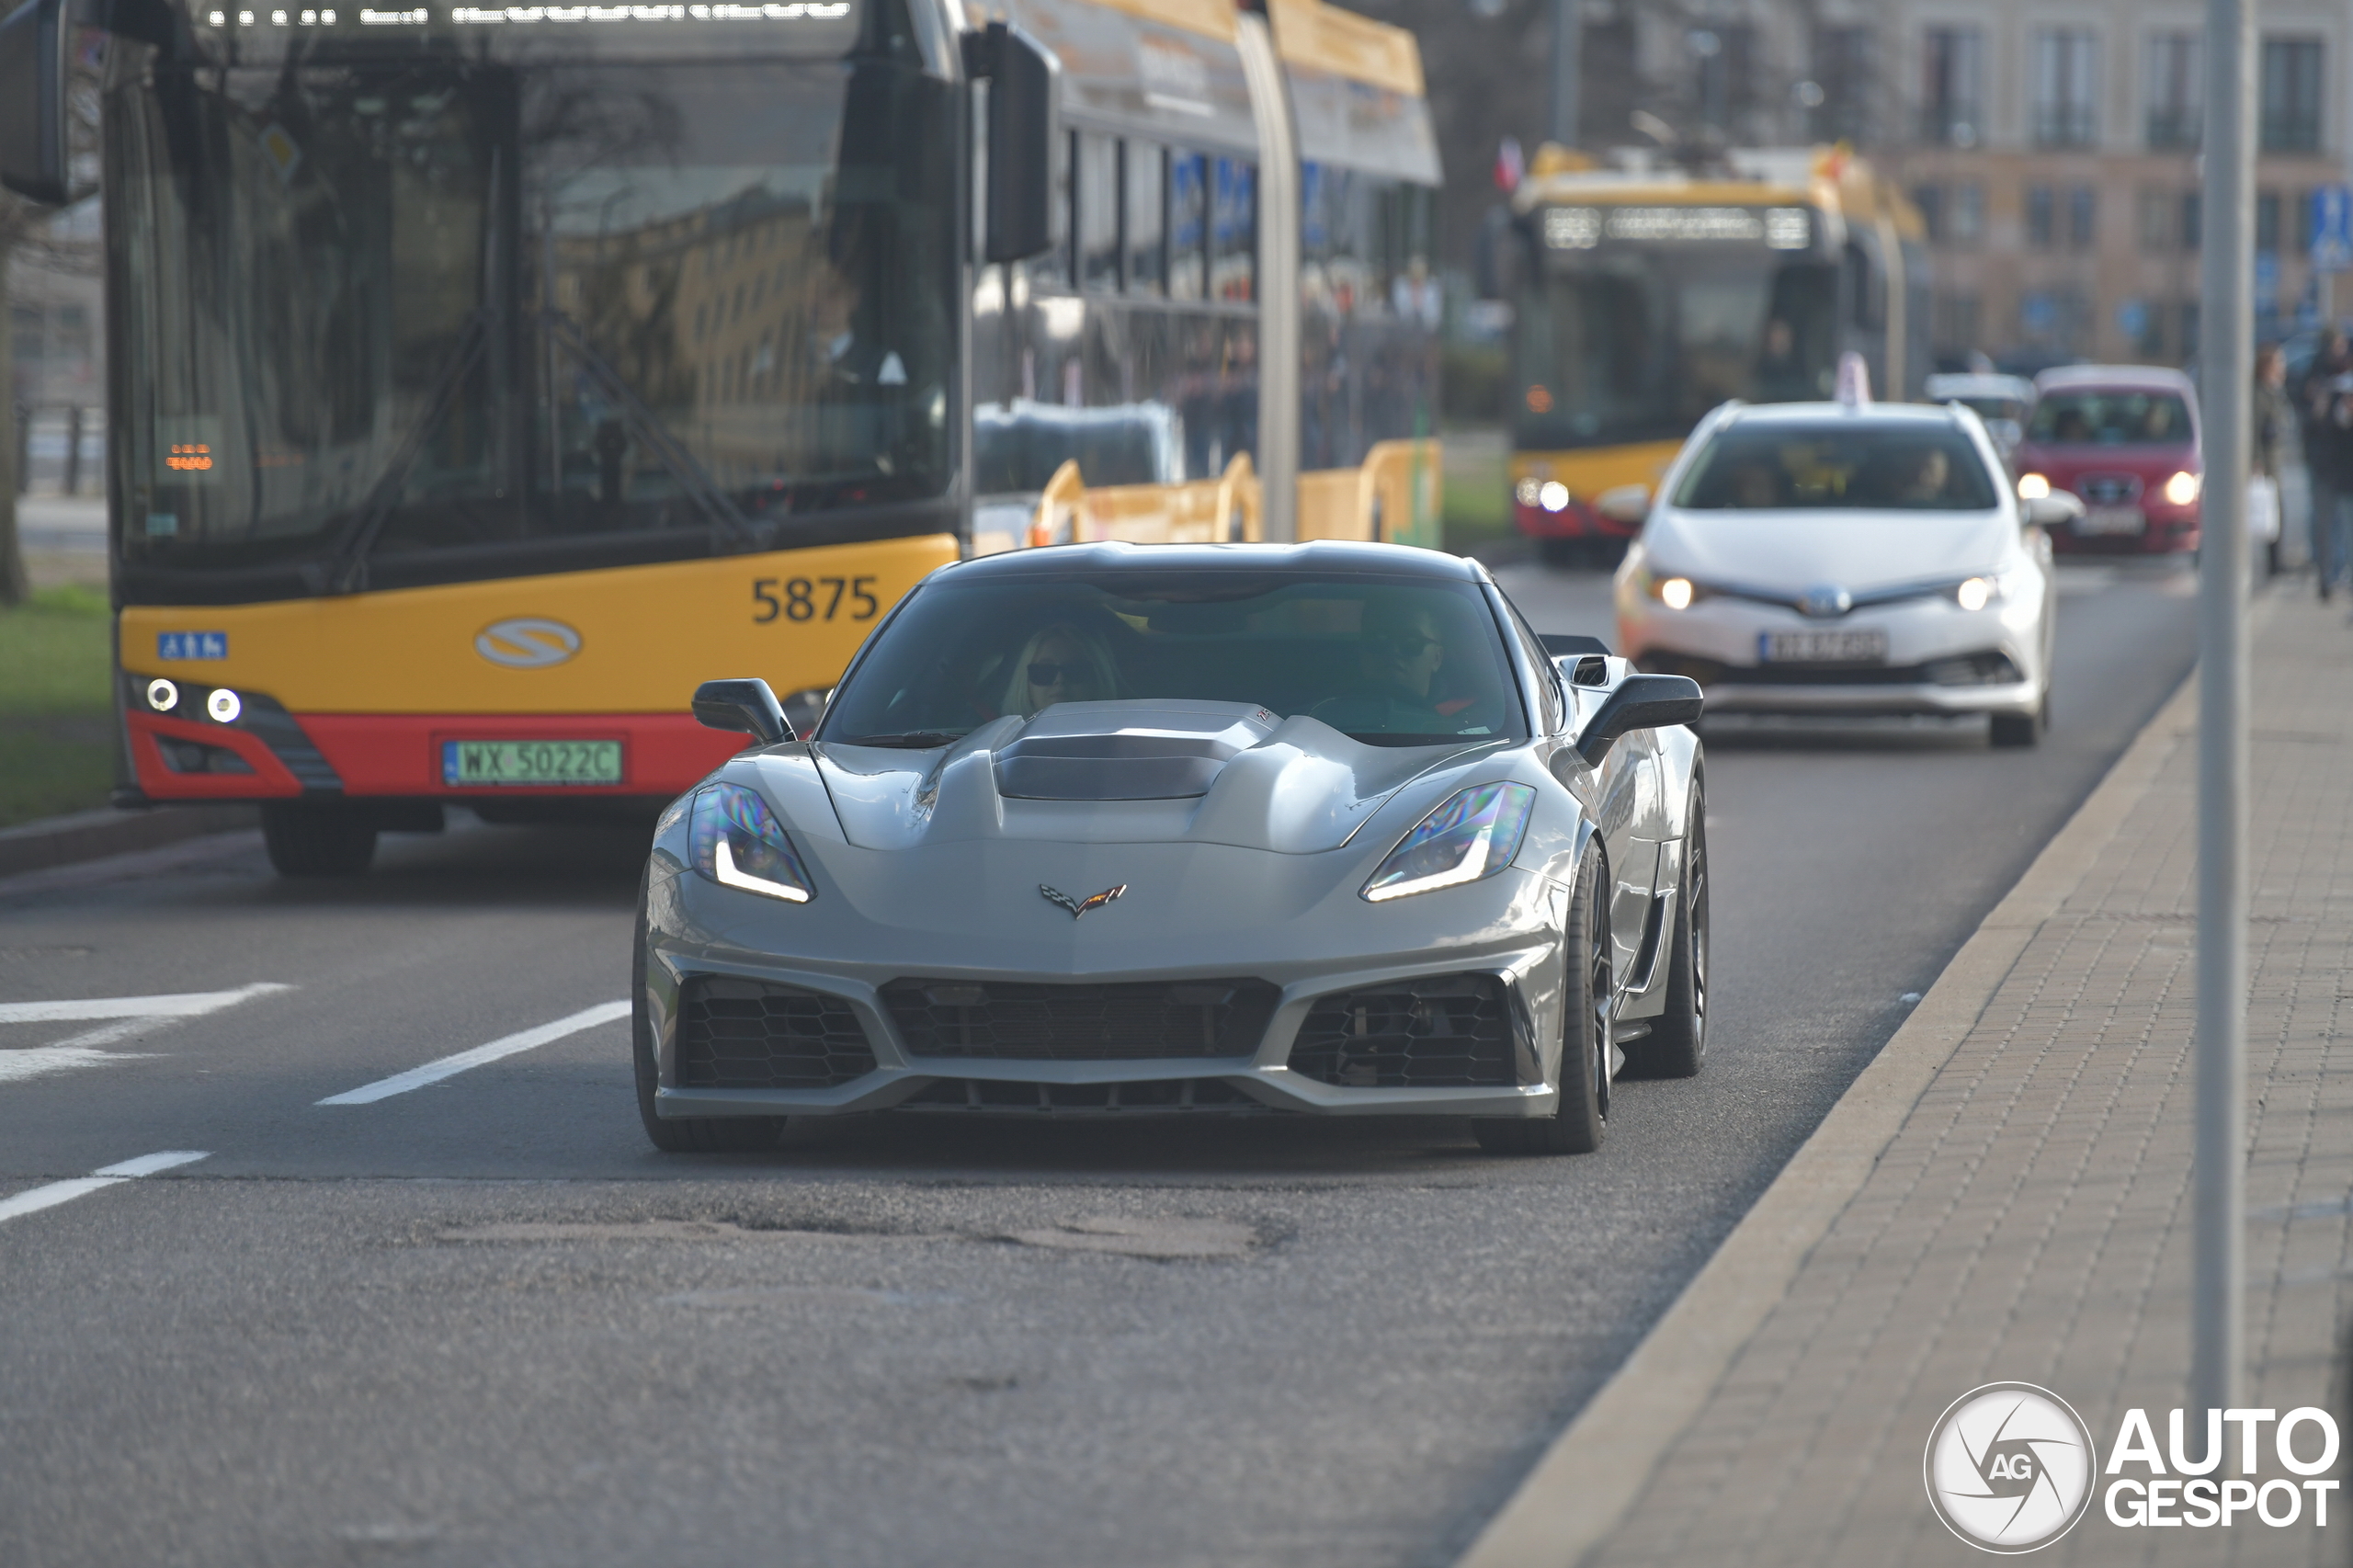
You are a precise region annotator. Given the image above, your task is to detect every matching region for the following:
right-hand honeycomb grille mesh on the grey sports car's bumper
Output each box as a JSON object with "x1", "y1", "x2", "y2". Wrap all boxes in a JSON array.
[{"x1": 1291, "y1": 974, "x2": 1518, "y2": 1087}]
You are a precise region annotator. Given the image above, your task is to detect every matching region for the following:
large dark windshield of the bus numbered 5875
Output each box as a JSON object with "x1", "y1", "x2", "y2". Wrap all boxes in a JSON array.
[{"x1": 108, "y1": 5, "x2": 958, "y2": 600}]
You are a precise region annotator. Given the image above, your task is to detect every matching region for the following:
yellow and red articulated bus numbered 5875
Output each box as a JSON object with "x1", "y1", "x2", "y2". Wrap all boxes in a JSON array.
[{"x1": 0, "y1": 0, "x2": 1438, "y2": 876}]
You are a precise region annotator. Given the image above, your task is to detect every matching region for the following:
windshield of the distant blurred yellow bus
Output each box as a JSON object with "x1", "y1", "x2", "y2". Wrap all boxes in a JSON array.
[{"x1": 1513, "y1": 244, "x2": 1837, "y2": 449}]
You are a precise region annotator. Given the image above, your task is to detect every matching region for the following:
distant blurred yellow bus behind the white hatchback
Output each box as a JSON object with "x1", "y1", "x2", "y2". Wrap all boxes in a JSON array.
[{"x1": 1506, "y1": 146, "x2": 1929, "y2": 561}]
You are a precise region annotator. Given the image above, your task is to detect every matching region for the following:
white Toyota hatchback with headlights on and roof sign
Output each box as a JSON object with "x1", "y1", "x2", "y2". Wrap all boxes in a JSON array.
[{"x1": 1602, "y1": 403, "x2": 2073, "y2": 746}]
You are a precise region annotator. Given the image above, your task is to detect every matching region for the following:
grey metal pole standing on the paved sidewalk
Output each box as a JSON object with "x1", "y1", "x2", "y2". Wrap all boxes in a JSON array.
[{"x1": 2188, "y1": 0, "x2": 2256, "y2": 1410}]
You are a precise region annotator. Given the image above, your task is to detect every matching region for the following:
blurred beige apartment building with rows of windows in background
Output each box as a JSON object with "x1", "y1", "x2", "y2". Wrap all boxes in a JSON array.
[{"x1": 1534, "y1": 0, "x2": 2353, "y2": 368}]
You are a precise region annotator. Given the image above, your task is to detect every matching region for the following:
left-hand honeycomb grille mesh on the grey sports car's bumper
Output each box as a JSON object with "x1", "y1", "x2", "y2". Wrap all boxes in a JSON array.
[{"x1": 677, "y1": 974, "x2": 875, "y2": 1087}]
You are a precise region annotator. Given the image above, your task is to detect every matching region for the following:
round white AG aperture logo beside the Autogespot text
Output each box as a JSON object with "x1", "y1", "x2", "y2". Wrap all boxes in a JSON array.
[{"x1": 1923, "y1": 1382, "x2": 2097, "y2": 1554}]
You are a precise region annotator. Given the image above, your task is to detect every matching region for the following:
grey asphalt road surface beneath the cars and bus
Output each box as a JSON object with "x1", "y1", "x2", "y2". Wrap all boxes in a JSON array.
[{"x1": 0, "y1": 552, "x2": 2193, "y2": 1568}]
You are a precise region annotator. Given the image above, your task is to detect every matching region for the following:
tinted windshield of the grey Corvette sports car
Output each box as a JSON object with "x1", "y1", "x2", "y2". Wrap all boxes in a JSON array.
[{"x1": 816, "y1": 570, "x2": 1527, "y2": 746}]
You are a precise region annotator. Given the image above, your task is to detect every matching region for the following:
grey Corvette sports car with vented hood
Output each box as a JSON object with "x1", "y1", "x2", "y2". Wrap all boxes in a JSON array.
[{"x1": 631, "y1": 544, "x2": 1709, "y2": 1153}]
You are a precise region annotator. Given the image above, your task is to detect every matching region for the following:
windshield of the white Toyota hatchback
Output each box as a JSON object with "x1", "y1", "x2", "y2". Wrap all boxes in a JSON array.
[{"x1": 1676, "y1": 422, "x2": 1995, "y2": 511}]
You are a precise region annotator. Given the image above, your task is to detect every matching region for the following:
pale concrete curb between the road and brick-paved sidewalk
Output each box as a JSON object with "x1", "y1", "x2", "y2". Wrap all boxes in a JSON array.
[{"x1": 1457, "y1": 640, "x2": 2221, "y2": 1568}]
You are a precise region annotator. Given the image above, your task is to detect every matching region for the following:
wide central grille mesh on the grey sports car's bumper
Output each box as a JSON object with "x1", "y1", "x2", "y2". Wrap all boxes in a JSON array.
[{"x1": 882, "y1": 980, "x2": 1280, "y2": 1062}]
